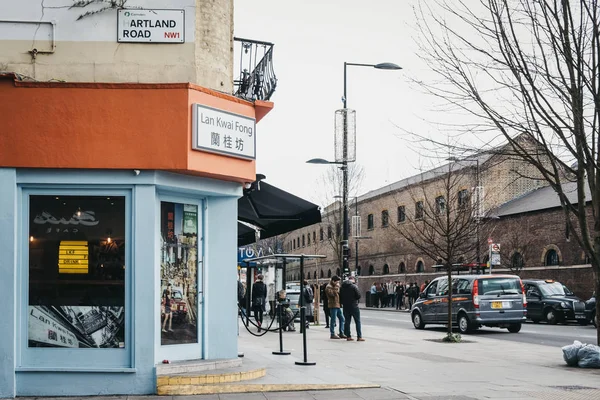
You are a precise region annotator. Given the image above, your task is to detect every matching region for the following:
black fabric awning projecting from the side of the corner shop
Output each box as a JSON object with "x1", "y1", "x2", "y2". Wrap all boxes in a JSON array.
[{"x1": 238, "y1": 180, "x2": 321, "y2": 246}]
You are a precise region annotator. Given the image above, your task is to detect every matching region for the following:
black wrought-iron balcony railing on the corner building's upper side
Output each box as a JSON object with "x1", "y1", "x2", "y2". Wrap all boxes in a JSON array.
[{"x1": 233, "y1": 37, "x2": 277, "y2": 101}]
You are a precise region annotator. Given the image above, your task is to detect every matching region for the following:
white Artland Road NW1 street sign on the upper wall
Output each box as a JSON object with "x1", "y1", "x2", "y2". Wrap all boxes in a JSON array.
[{"x1": 117, "y1": 9, "x2": 185, "y2": 43}]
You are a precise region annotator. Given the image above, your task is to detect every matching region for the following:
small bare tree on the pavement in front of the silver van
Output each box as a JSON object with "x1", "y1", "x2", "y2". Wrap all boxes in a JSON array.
[{"x1": 390, "y1": 163, "x2": 483, "y2": 340}]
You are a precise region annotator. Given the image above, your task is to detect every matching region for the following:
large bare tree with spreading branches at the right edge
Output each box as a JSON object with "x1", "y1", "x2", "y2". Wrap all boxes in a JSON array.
[{"x1": 416, "y1": 0, "x2": 600, "y2": 341}]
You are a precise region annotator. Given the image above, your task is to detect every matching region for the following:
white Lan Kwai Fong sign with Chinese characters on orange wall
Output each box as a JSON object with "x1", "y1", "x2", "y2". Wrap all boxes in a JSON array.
[{"x1": 192, "y1": 104, "x2": 256, "y2": 160}]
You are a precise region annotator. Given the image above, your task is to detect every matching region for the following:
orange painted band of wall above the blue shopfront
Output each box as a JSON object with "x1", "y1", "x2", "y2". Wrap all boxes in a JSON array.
[{"x1": 0, "y1": 77, "x2": 268, "y2": 182}]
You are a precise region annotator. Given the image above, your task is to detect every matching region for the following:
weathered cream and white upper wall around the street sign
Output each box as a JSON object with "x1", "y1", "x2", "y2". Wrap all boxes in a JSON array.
[{"x1": 0, "y1": 0, "x2": 233, "y2": 92}]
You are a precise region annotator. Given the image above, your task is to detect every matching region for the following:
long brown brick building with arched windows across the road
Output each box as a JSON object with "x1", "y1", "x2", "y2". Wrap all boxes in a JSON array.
[{"x1": 280, "y1": 141, "x2": 593, "y2": 298}]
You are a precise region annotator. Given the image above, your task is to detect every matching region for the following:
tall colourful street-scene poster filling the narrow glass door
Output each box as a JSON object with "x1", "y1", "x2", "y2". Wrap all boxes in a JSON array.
[{"x1": 160, "y1": 202, "x2": 198, "y2": 345}]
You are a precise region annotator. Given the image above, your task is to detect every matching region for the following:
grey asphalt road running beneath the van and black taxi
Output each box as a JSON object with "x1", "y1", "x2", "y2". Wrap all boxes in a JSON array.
[{"x1": 360, "y1": 309, "x2": 596, "y2": 347}]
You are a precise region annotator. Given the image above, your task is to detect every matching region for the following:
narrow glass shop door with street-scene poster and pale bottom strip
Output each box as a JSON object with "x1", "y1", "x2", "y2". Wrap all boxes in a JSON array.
[{"x1": 159, "y1": 200, "x2": 203, "y2": 360}]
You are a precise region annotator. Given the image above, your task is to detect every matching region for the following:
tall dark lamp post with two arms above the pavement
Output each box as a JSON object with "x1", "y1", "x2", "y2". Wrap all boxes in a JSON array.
[{"x1": 308, "y1": 62, "x2": 402, "y2": 275}]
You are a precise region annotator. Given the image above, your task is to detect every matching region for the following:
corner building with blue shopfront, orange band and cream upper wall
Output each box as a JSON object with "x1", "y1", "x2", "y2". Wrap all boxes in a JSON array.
[{"x1": 0, "y1": 0, "x2": 275, "y2": 398}]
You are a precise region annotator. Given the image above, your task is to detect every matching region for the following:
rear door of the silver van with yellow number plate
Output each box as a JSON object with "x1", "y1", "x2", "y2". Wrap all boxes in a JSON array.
[{"x1": 478, "y1": 275, "x2": 524, "y2": 322}]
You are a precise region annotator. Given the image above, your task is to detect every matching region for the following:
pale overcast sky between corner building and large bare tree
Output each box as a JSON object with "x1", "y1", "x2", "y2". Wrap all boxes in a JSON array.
[{"x1": 234, "y1": 0, "x2": 454, "y2": 206}]
